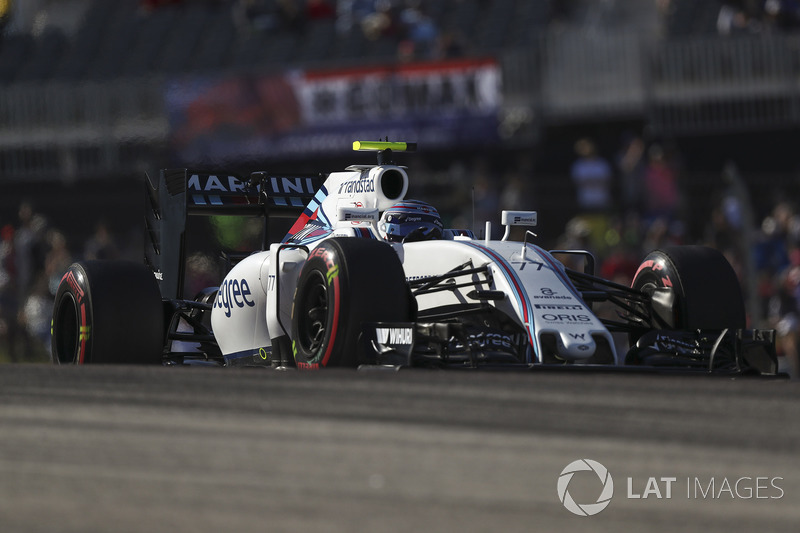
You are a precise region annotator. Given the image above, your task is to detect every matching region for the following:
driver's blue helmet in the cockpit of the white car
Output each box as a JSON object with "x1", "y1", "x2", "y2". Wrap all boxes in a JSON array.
[{"x1": 378, "y1": 200, "x2": 443, "y2": 242}]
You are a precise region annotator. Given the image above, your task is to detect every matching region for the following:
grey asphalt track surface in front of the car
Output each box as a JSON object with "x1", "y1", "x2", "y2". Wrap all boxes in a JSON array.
[{"x1": 0, "y1": 365, "x2": 800, "y2": 533}]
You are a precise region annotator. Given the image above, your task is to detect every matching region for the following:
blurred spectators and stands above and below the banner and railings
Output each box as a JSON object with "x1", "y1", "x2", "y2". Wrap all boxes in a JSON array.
[{"x1": 0, "y1": 0, "x2": 800, "y2": 374}]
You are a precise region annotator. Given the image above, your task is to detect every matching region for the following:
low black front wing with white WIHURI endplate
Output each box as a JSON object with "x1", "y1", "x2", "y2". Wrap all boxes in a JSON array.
[{"x1": 359, "y1": 322, "x2": 778, "y2": 375}]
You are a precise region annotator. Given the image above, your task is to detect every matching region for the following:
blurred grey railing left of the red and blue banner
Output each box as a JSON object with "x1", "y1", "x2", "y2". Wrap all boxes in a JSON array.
[{"x1": 0, "y1": 79, "x2": 169, "y2": 180}]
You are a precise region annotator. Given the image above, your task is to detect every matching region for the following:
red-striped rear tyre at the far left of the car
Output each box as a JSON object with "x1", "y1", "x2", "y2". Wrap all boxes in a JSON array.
[{"x1": 51, "y1": 261, "x2": 164, "y2": 364}]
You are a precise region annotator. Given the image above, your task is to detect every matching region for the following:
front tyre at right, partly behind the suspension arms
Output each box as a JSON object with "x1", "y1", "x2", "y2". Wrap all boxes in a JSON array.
[{"x1": 631, "y1": 246, "x2": 746, "y2": 341}]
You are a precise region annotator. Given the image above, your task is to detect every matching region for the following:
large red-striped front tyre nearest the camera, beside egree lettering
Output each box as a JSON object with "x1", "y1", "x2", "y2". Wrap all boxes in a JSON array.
[{"x1": 292, "y1": 237, "x2": 413, "y2": 368}]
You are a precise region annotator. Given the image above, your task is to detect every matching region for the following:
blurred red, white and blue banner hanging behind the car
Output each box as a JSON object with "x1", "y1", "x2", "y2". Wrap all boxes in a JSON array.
[{"x1": 166, "y1": 59, "x2": 502, "y2": 164}]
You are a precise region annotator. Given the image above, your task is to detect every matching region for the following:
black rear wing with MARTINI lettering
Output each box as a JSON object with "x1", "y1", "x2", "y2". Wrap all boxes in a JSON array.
[{"x1": 144, "y1": 168, "x2": 325, "y2": 299}]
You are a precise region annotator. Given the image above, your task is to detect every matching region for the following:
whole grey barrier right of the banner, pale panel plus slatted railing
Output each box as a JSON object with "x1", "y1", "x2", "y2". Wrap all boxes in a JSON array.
[{"x1": 503, "y1": 32, "x2": 800, "y2": 134}]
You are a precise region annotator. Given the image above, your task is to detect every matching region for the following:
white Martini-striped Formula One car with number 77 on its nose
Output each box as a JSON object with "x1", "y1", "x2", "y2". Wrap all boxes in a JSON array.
[{"x1": 52, "y1": 142, "x2": 777, "y2": 374}]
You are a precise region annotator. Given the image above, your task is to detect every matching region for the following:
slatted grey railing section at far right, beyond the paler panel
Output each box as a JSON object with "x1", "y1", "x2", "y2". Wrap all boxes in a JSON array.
[{"x1": 647, "y1": 35, "x2": 800, "y2": 134}]
